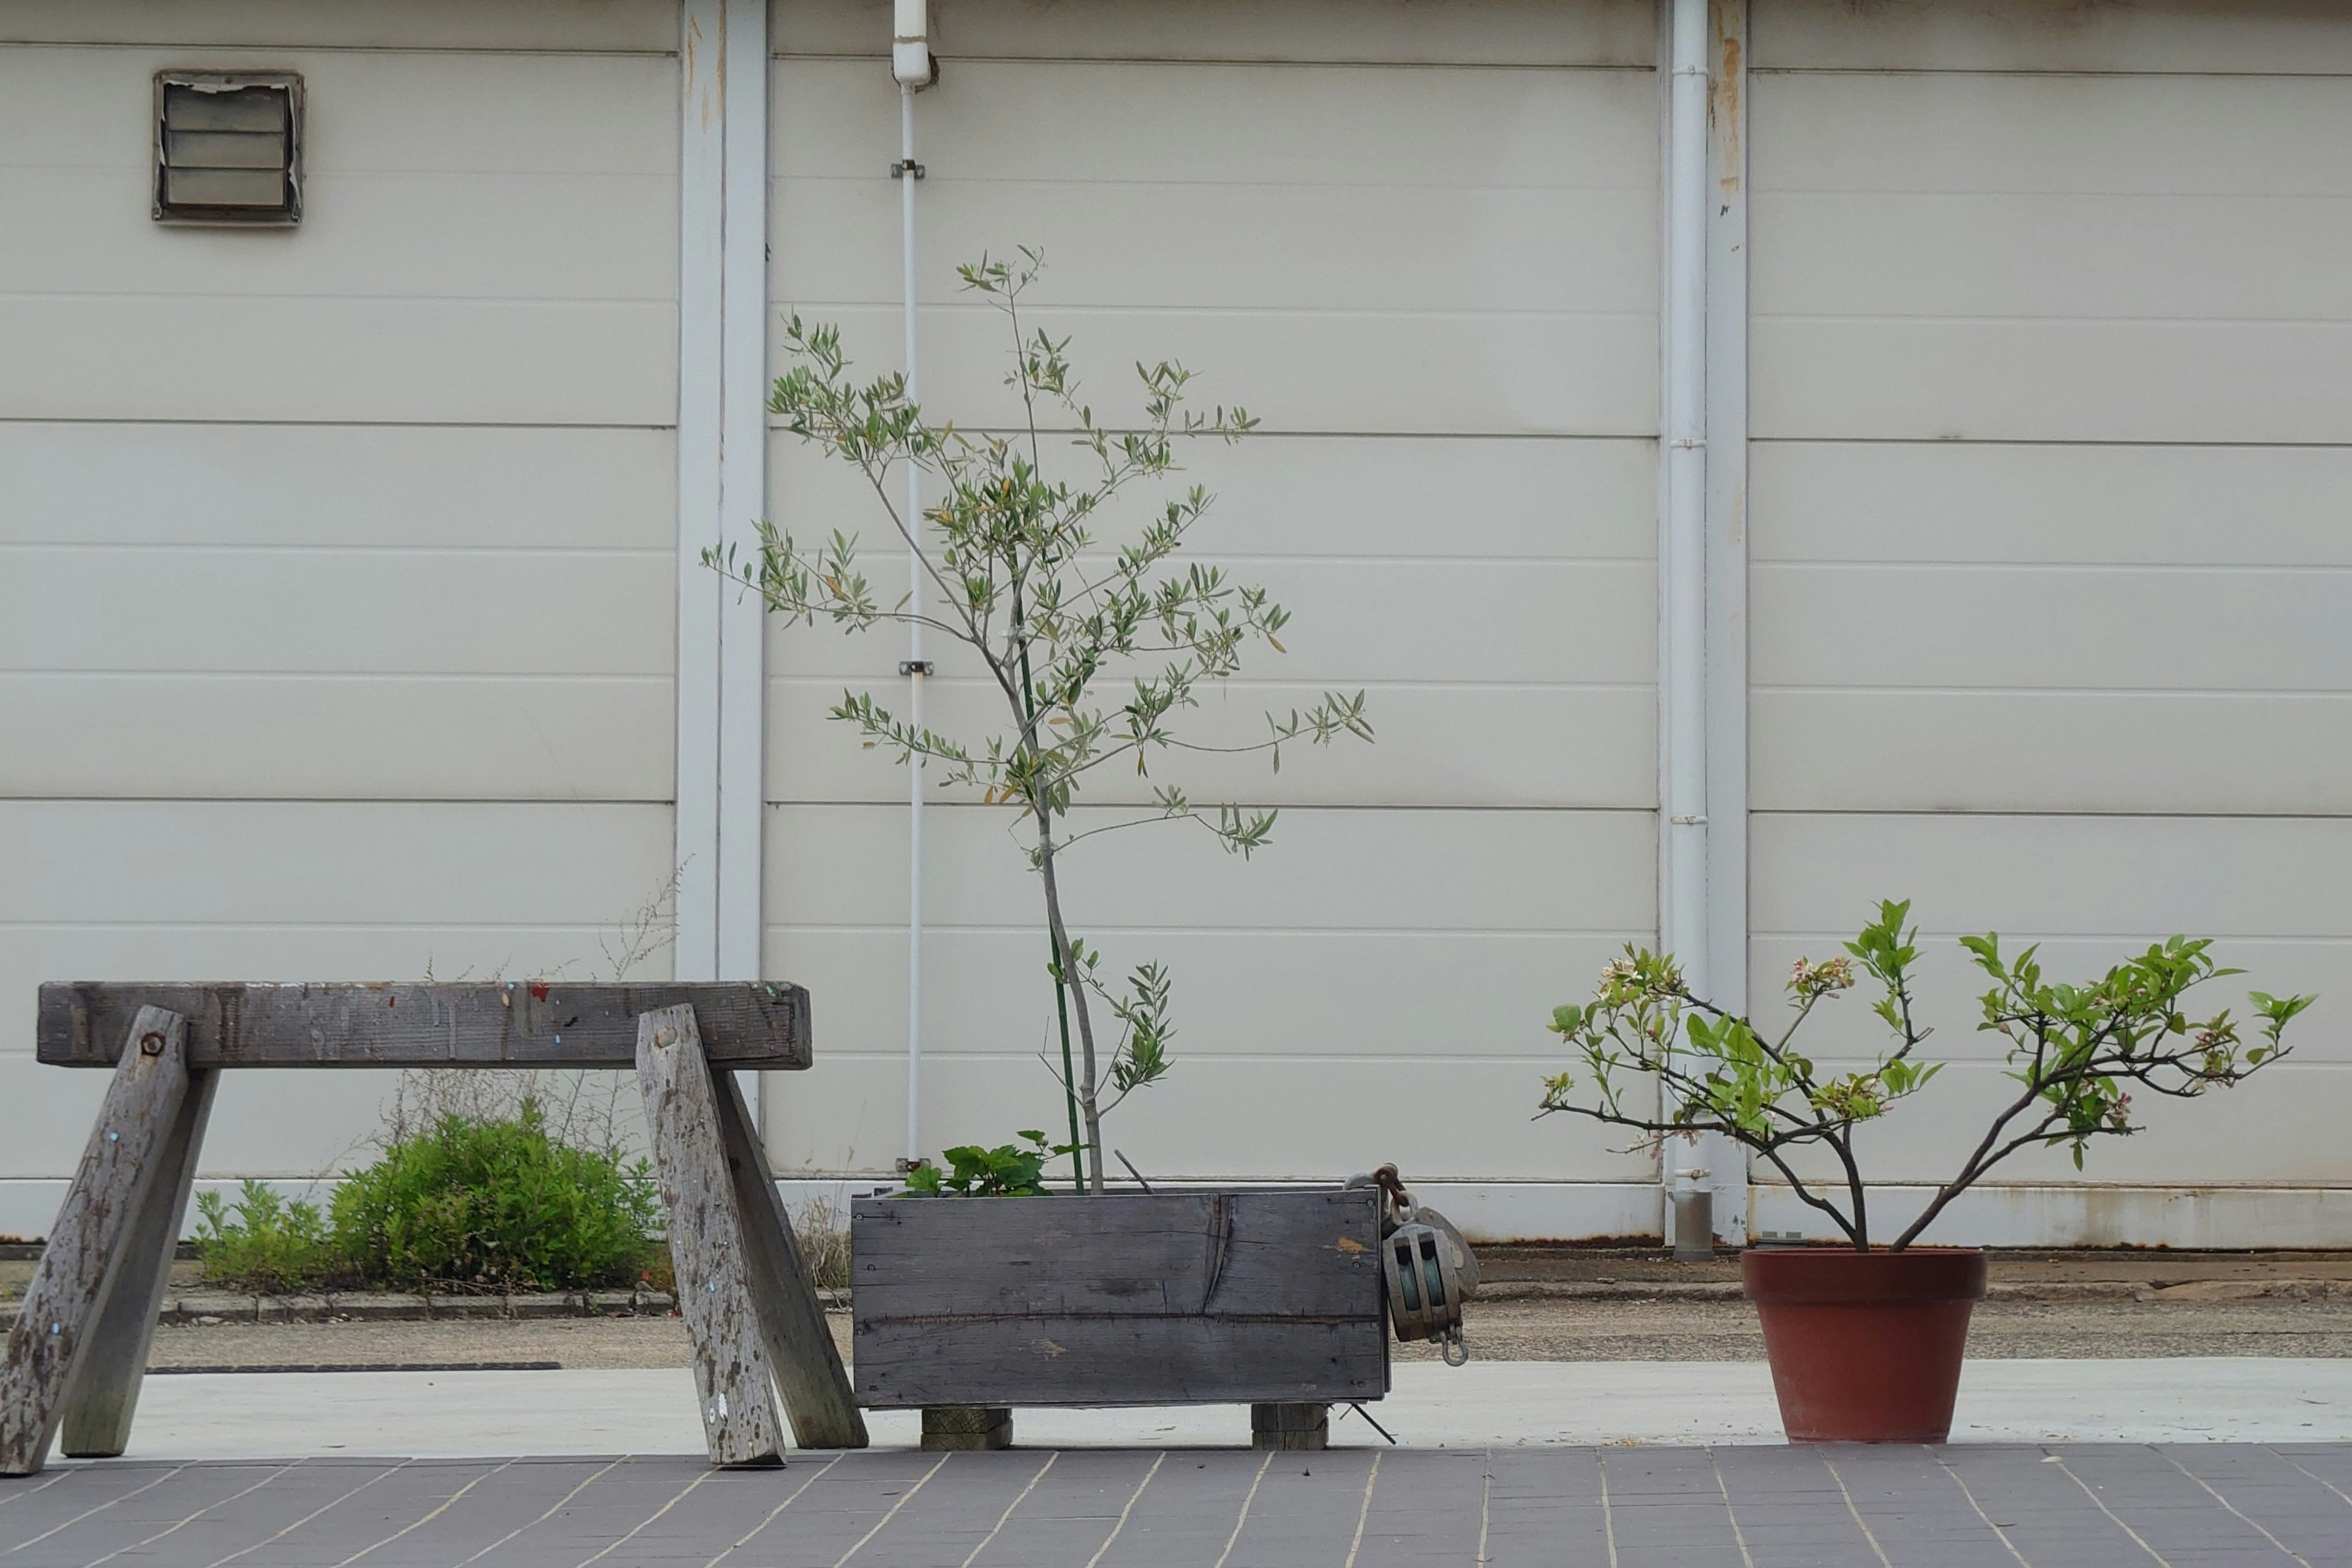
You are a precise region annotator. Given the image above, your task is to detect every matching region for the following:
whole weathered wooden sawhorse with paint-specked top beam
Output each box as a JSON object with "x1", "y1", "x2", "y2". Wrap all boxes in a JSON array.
[{"x1": 0, "y1": 980, "x2": 865, "y2": 1476}]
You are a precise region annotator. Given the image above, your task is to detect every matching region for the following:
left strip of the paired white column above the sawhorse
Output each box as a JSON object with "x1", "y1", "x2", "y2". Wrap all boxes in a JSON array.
[{"x1": 673, "y1": 0, "x2": 727, "y2": 980}]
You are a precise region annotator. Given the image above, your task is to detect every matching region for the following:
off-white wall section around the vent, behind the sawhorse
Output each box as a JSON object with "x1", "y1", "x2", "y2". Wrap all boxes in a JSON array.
[{"x1": 0, "y1": 0, "x2": 677, "y2": 1232}]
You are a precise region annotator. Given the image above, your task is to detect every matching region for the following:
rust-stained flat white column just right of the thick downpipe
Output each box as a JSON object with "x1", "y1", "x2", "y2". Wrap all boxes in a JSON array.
[{"x1": 1705, "y1": 0, "x2": 1747, "y2": 1243}]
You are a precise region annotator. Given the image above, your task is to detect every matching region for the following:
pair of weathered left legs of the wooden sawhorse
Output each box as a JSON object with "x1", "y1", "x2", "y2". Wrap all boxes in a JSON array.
[{"x1": 0, "y1": 1006, "x2": 214, "y2": 1476}]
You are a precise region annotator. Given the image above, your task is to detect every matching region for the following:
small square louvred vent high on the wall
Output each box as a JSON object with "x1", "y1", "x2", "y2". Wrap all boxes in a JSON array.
[{"x1": 155, "y1": 70, "x2": 301, "y2": 228}]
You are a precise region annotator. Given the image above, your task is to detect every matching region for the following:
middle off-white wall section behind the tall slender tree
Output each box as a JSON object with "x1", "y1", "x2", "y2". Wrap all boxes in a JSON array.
[{"x1": 769, "y1": 0, "x2": 1658, "y2": 1194}]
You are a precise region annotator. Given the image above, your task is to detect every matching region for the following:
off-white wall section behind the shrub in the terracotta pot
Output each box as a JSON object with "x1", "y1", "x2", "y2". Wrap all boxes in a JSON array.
[{"x1": 1750, "y1": 0, "x2": 2352, "y2": 1243}]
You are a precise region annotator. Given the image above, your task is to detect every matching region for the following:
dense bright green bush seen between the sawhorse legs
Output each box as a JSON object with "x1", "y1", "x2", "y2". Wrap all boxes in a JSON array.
[{"x1": 331, "y1": 1098, "x2": 661, "y2": 1291}]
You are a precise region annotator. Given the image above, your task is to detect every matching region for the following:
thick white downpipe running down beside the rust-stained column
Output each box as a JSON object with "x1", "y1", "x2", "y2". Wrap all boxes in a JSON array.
[{"x1": 1658, "y1": 0, "x2": 1710, "y2": 1232}]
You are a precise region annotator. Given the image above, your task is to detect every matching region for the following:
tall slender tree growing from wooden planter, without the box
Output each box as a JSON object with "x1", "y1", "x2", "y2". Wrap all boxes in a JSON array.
[{"x1": 703, "y1": 249, "x2": 1371, "y2": 1192}]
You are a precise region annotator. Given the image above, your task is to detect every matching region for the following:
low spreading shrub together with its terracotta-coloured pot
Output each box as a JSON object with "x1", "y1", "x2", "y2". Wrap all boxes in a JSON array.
[{"x1": 1538, "y1": 903, "x2": 2315, "y2": 1444}]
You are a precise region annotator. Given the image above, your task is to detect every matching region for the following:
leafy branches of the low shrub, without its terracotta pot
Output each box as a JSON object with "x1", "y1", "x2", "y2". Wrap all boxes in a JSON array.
[{"x1": 1538, "y1": 903, "x2": 2316, "y2": 1251}]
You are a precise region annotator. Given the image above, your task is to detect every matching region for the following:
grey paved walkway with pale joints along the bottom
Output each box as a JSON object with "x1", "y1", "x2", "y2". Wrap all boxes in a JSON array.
[{"x1": 0, "y1": 1444, "x2": 2352, "y2": 1568}]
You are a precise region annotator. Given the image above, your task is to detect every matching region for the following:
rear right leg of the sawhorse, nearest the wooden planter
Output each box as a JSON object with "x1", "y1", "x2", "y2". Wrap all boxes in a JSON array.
[{"x1": 713, "y1": 1072, "x2": 865, "y2": 1448}]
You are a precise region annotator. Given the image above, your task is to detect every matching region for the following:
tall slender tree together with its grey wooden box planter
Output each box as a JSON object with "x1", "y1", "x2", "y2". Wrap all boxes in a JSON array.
[{"x1": 706, "y1": 252, "x2": 1388, "y2": 1446}]
